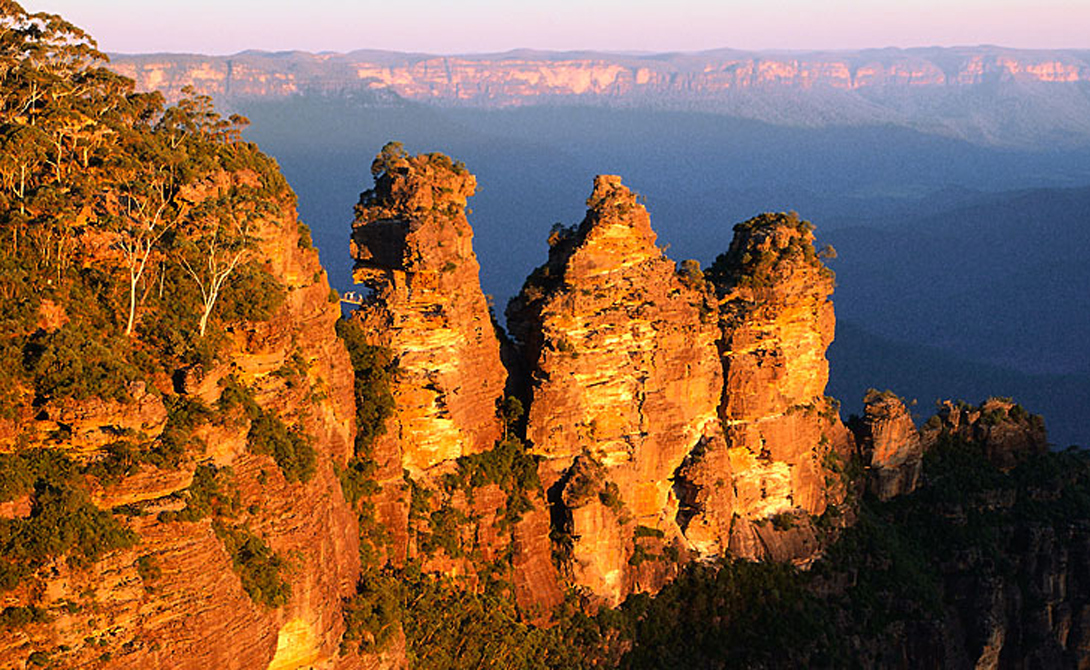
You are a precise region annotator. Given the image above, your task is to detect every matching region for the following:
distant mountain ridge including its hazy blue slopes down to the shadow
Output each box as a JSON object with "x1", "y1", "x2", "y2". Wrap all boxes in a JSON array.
[{"x1": 111, "y1": 47, "x2": 1090, "y2": 146}]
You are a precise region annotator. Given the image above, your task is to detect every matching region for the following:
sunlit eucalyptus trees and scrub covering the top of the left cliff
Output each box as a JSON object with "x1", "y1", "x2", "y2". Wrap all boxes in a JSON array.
[{"x1": 0, "y1": 1, "x2": 292, "y2": 416}]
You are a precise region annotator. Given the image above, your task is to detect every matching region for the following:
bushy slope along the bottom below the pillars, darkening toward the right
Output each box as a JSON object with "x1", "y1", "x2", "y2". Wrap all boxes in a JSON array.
[{"x1": 337, "y1": 437, "x2": 1090, "y2": 669}]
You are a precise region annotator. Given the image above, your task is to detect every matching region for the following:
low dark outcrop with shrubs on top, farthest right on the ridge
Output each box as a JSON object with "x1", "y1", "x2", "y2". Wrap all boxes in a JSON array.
[{"x1": 921, "y1": 398, "x2": 1049, "y2": 470}]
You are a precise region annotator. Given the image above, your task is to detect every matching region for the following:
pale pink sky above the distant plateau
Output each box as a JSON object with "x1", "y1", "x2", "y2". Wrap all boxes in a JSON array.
[{"x1": 22, "y1": 0, "x2": 1090, "y2": 54}]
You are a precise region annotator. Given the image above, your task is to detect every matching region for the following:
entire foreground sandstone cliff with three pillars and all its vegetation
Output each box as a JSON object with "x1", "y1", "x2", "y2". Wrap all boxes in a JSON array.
[{"x1": 0, "y1": 3, "x2": 1090, "y2": 670}]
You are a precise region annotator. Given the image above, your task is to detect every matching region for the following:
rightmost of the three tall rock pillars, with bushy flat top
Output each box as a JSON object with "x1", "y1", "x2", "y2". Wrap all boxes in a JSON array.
[{"x1": 709, "y1": 212, "x2": 851, "y2": 558}]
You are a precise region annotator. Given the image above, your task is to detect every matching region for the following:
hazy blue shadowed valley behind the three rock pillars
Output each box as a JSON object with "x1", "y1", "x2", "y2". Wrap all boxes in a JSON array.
[{"x1": 206, "y1": 78, "x2": 1090, "y2": 446}]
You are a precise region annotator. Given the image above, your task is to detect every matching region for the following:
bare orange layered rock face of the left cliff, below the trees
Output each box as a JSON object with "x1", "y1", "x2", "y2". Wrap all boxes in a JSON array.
[{"x1": 0, "y1": 181, "x2": 360, "y2": 669}]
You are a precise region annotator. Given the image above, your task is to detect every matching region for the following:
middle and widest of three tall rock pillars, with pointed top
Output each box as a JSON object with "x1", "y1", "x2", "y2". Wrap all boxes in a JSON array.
[{"x1": 508, "y1": 175, "x2": 722, "y2": 602}]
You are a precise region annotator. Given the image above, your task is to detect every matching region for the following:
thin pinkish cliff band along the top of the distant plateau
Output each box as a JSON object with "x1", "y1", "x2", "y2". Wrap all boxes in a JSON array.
[{"x1": 112, "y1": 47, "x2": 1090, "y2": 106}]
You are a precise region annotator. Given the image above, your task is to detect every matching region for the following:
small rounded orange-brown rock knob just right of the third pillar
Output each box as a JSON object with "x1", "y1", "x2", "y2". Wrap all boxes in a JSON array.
[{"x1": 852, "y1": 389, "x2": 923, "y2": 500}]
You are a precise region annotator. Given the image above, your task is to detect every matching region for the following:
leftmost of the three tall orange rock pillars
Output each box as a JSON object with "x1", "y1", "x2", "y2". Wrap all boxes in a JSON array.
[{"x1": 352, "y1": 149, "x2": 507, "y2": 475}]
